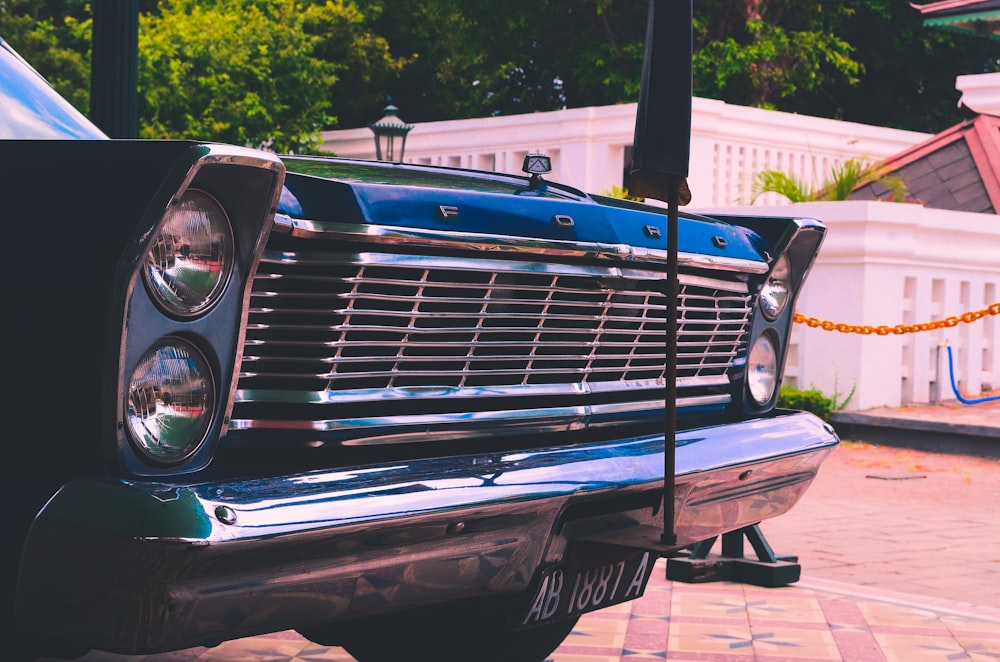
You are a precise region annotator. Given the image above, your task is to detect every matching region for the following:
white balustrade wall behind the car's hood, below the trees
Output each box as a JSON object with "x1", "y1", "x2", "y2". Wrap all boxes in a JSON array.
[{"x1": 323, "y1": 98, "x2": 928, "y2": 206}]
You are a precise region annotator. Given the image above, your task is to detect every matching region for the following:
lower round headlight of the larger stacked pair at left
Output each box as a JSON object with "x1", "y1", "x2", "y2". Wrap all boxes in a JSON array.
[{"x1": 125, "y1": 338, "x2": 215, "y2": 464}]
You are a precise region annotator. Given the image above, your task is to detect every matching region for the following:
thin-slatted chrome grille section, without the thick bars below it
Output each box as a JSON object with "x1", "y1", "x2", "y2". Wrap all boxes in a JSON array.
[{"x1": 241, "y1": 253, "x2": 750, "y2": 391}]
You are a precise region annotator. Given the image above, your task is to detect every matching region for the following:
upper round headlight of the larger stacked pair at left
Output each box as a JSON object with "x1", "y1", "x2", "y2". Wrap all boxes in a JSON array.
[{"x1": 143, "y1": 189, "x2": 233, "y2": 317}]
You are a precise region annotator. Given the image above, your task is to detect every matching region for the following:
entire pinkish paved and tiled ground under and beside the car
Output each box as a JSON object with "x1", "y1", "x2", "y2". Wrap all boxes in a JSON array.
[{"x1": 35, "y1": 396, "x2": 1000, "y2": 662}]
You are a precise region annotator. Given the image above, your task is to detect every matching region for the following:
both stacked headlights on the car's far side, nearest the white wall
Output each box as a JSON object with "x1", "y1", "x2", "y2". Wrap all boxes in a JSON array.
[{"x1": 747, "y1": 255, "x2": 792, "y2": 406}]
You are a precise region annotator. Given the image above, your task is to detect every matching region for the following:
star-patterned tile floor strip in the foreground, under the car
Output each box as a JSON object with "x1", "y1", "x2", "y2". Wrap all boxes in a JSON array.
[{"x1": 35, "y1": 562, "x2": 1000, "y2": 662}]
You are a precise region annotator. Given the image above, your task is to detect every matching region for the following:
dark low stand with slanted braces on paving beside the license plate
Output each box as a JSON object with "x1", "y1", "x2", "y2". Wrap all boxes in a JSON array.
[{"x1": 667, "y1": 524, "x2": 802, "y2": 588}]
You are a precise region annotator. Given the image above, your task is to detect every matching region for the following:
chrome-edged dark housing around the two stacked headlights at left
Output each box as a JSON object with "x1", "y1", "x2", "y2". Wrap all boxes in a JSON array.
[{"x1": 104, "y1": 143, "x2": 285, "y2": 477}]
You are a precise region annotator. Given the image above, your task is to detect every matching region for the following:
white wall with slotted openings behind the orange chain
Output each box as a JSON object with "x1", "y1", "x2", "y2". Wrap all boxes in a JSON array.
[{"x1": 698, "y1": 201, "x2": 1000, "y2": 411}]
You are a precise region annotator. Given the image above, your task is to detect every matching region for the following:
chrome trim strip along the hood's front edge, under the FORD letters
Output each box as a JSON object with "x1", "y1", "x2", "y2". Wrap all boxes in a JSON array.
[{"x1": 274, "y1": 214, "x2": 768, "y2": 274}]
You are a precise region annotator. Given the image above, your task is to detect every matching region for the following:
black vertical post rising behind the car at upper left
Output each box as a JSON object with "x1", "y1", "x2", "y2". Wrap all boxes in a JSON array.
[{"x1": 90, "y1": 0, "x2": 139, "y2": 138}]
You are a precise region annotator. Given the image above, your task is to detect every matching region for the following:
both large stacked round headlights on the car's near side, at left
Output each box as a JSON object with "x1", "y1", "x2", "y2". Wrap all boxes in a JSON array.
[{"x1": 125, "y1": 189, "x2": 234, "y2": 465}]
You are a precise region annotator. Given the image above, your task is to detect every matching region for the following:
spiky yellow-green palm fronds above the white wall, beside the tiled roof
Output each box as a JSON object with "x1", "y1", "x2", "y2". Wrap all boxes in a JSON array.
[{"x1": 750, "y1": 158, "x2": 909, "y2": 204}]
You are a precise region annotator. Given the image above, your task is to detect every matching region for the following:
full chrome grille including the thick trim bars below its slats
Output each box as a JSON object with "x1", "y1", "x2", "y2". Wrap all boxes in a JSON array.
[{"x1": 230, "y1": 234, "x2": 756, "y2": 444}]
